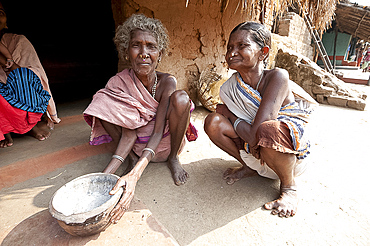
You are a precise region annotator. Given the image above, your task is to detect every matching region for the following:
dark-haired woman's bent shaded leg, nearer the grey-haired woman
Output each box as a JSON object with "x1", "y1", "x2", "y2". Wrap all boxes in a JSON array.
[{"x1": 204, "y1": 113, "x2": 257, "y2": 184}]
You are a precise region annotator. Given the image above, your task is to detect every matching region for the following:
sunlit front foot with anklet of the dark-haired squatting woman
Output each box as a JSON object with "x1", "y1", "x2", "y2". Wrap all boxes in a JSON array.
[{"x1": 265, "y1": 186, "x2": 298, "y2": 217}]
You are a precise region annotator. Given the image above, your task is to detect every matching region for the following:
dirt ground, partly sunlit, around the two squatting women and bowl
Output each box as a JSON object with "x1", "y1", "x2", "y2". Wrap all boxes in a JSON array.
[{"x1": 0, "y1": 81, "x2": 370, "y2": 246}]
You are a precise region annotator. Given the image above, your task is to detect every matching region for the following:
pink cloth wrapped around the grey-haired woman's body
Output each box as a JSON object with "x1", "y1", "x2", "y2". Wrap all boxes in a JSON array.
[{"x1": 84, "y1": 69, "x2": 177, "y2": 161}]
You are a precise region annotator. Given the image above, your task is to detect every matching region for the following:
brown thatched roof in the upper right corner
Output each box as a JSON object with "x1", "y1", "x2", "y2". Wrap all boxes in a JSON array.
[{"x1": 335, "y1": 3, "x2": 370, "y2": 41}]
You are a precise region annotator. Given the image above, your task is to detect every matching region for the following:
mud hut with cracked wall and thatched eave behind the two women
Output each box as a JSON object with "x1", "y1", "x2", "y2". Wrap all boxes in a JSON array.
[{"x1": 112, "y1": 0, "x2": 342, "y2": 109}]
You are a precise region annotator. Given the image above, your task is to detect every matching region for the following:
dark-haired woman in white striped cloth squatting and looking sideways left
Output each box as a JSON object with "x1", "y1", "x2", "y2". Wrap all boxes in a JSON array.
[{"x1": 204, "y1": 22, "x2": 316, "y2": 217}]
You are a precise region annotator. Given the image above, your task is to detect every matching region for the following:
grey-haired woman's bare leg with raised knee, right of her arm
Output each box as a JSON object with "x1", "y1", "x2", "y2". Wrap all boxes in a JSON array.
[{"x1": 167, "y1": 90, "x2": 191, "y2": 185}]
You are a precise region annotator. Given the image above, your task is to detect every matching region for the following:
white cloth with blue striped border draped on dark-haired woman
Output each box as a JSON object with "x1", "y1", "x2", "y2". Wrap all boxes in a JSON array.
[{"x1": 220, "y1": 73, "x2": 317, "y2": 159}]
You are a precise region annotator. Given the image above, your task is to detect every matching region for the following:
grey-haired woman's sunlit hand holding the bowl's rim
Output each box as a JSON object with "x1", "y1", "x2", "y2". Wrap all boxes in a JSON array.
[{"x1": 109, "y1": 173, "x2": 137, "y2": 224}]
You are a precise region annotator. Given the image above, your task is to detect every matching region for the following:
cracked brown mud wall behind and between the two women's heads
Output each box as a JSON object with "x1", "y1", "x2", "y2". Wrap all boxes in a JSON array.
[{"x1": 112, "y1": 0, "x2": 268, "y2": 98}]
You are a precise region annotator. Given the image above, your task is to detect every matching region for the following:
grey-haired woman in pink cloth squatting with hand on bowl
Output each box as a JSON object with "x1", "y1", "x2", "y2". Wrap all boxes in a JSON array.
[{"x1": 84, "y1": 15, "x2": 196, "y2": 223}]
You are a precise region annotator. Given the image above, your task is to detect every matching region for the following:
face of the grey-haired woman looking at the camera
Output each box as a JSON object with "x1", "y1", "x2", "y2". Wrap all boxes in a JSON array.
[{"x1": 128, "y1": 30, "x2": 161, "y2": 76}]
